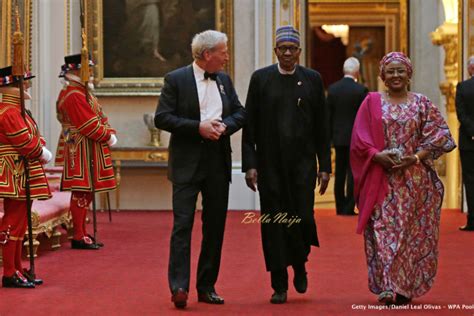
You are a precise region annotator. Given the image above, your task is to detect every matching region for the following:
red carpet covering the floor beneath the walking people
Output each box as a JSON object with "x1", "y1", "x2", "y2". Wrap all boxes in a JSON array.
[{"x1": 0, "y1": 210, "x2": 474, "y2": 316}]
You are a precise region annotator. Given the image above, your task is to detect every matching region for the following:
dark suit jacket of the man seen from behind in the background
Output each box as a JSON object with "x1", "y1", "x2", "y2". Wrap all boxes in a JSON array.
[{"x1": 327, "y1": 78, "x2": 368, "y2": 146}]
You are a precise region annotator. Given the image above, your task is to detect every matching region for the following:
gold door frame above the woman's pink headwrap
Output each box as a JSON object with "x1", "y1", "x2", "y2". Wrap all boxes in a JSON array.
[{"x1": 307, "y1": 0, "x2": 408, "y2": 62}]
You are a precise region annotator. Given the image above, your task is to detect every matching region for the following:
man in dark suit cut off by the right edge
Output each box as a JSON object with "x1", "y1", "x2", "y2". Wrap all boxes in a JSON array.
[{"x1": 456, "y1": 56, "x2": 474, "y2": 231}]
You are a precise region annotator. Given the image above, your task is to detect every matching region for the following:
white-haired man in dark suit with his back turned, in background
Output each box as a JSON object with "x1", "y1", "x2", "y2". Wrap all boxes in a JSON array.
[{"x1": 327, "y1": 57, "x2": 368, "y2": 215}]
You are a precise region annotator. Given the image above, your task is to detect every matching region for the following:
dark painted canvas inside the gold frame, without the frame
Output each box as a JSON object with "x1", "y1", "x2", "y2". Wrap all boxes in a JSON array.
[{"x1": 102, "y1": 0, "x2": 216, "y2": 78}]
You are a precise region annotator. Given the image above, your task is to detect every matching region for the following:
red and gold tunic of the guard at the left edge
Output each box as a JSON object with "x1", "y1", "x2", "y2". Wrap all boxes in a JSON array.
[{"x1": 0, "y1": 93, "x2": 51, "y2": 200}]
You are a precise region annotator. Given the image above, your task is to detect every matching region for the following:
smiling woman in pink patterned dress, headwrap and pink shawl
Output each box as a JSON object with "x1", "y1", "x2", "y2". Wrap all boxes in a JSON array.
[{"x1": 351, "y1": 52, "x2": 456, "y2": 304}]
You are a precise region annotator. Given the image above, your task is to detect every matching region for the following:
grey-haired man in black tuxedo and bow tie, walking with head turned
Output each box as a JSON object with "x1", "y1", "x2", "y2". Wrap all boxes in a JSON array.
[{"x1": 155, "y1": 30, "x2": 245, "y2": 308}]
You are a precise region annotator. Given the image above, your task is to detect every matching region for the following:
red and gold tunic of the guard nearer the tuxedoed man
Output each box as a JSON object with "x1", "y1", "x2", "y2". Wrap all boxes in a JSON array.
[{"x1": 56, "y1": 78, "x2": 116, "y2": 192}]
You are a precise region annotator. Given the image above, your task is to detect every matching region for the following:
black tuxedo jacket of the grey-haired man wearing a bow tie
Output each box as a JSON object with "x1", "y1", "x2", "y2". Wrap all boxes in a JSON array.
[{"x1": 155, "y1": 65, "x2": 245, "y2": 184}]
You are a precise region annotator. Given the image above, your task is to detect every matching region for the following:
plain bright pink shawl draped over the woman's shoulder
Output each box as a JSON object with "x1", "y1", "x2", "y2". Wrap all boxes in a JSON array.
[{"x1": 350, "y1": 92, "x2": 388, "y2": 234}]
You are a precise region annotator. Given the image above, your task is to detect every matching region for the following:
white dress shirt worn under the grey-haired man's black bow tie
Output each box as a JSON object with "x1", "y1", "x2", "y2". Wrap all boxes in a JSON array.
[{"x1": 193, "y1": 62, "x2": 222, "y2": 122}]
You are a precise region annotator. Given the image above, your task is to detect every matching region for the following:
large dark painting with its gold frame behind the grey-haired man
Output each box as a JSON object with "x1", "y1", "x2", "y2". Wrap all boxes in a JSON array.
[{"x1": 86, "y1": 0, "x2": 233, "y2": 96}]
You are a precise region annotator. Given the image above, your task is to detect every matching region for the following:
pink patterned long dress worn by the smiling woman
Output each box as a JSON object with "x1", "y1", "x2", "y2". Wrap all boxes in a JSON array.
[{"x1": 364, "y1": 93, "x2": 456, "y2": 298}]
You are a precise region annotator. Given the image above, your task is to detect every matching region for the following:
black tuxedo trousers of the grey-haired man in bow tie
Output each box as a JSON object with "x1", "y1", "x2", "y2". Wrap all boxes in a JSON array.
[{"x1": 168, "y1": 141, "x2": 230, "y2": 293}]
